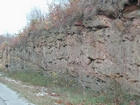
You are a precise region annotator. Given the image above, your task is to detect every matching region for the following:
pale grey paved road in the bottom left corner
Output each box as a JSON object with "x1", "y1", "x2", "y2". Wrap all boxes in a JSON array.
[{"x1": 0, "y1": 83, "x2": 33, "y2": 105}]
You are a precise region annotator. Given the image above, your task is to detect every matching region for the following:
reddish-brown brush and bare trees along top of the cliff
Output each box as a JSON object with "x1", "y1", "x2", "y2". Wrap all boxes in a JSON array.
[{"x1": 1, "y1": 0, "x2": 140, "y2": 50}]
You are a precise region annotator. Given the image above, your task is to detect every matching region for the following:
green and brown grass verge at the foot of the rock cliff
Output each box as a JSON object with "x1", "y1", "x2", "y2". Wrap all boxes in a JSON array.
[{"x1": 1, "y1": 71, "x2": 140, "y2": 105}]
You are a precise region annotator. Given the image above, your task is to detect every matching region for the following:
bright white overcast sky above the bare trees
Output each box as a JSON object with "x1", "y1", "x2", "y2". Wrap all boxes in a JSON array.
[{"x1": 0, "y1": 0, "x2": 49, "y2": 35}]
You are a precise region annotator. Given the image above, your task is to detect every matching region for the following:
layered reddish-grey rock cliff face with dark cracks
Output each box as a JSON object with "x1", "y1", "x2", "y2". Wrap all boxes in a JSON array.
[{"x1": 2, "y1": 0, "x2": 140, "y2": 95}]
